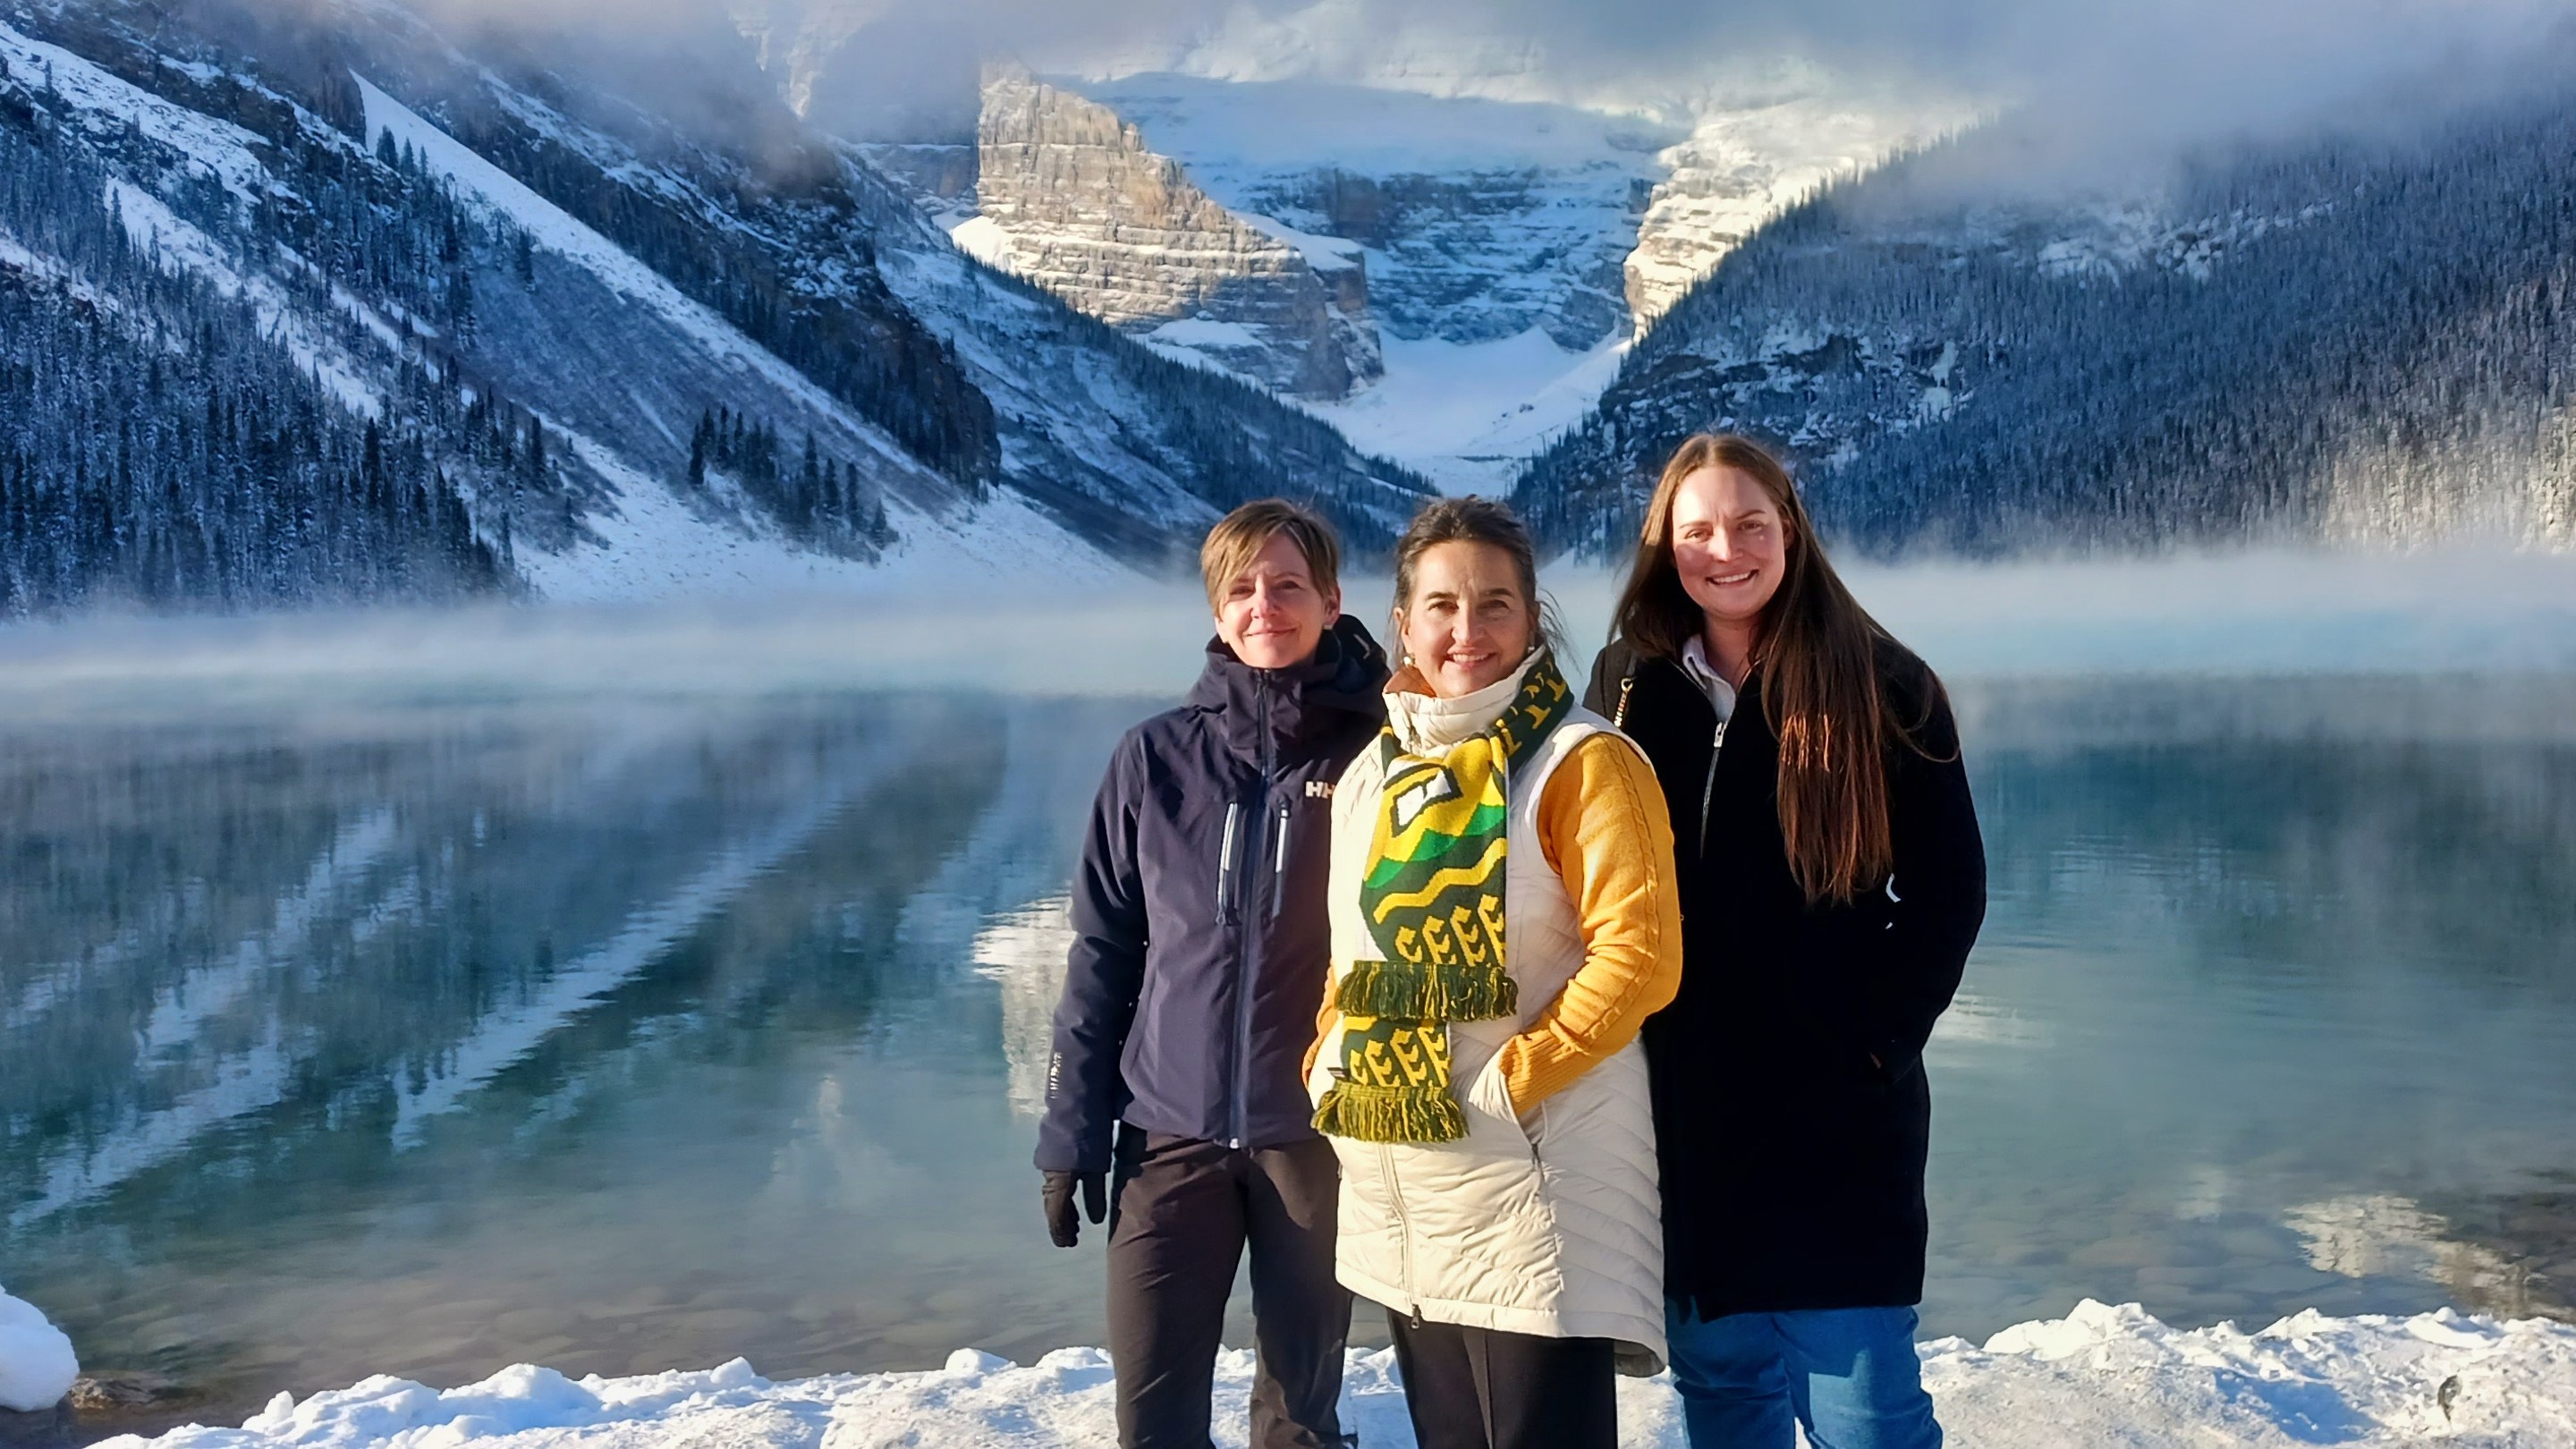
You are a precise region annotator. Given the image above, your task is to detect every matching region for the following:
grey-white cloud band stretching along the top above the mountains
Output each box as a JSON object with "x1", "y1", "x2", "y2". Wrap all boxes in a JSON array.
[{"x1": 386, "y1": 0, "x2": 2571, "y2": 167}]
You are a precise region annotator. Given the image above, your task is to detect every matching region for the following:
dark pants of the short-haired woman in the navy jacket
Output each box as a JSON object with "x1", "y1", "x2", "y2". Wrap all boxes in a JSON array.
[{"x1": 1110, "y1": 1127, "x2": 1350, "y2": 1449}]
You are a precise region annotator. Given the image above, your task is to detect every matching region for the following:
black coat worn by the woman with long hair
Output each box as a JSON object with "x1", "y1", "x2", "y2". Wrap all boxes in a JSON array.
[{"x1": 1584, "y1": 642, "x2": 1986, "y2": 1318}]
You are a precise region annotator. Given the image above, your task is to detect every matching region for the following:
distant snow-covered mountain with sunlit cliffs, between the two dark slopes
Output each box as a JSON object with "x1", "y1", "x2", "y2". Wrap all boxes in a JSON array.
[{"x1": 783, "y1": 0, "x2": 1976, "y2": 490}]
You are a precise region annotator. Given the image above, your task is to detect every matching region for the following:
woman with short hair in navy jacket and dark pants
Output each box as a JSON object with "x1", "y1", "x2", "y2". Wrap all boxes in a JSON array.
[{"x1": 1038, "y1": 497, "x2": 1385, "y2": 1449}]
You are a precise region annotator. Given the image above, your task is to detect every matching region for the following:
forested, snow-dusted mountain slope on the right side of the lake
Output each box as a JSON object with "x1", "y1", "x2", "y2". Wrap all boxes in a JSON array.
[{"x1": 1514, "y1": 80, "x2": 2576, "y2": 555}]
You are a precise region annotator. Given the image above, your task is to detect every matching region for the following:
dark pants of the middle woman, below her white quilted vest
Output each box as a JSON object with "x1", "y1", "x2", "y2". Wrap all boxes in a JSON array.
[{"x1": 1385, "y1": 1309, "x2": 1618, "y2": 1449}]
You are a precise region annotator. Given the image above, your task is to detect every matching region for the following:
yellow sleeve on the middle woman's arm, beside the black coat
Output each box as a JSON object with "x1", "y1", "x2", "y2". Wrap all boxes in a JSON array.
[{"x1": 1499, "y1": 735, "x2": 1682, "y2": 1111}]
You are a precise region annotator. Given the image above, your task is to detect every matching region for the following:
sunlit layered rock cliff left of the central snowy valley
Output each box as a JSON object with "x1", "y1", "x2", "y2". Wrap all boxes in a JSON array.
[{"x1": 977, "y1": 70, "x2": 1378, "y2": 400}]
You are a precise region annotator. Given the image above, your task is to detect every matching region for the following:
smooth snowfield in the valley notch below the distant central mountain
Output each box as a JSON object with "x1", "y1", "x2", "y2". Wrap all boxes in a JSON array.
[{"x1": 1306, "y1": 327, "x2": 1628, "y2": 495}]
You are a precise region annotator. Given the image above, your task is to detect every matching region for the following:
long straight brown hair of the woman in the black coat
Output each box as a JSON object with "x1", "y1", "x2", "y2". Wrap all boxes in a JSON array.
[{"x1": 1613, "y1": 433, "x2": 1943, "y2": 902}]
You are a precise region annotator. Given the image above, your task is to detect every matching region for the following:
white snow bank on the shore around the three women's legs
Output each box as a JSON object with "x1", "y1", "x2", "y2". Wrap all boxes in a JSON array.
[{"x1": 111, "y1": 1300, "x2": 2576, "y2": 1449}]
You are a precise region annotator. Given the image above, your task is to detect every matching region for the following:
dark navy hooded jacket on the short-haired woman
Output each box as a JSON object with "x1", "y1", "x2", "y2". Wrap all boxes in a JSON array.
[{"x1": 1038, "y1": 616, "x2": 1385, "y2": 1174}]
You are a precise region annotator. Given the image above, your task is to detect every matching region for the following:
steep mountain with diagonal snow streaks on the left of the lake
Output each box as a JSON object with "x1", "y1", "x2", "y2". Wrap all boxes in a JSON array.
[{"x1": 0, "y1": 0, "x2": 1419, "y2": 608}]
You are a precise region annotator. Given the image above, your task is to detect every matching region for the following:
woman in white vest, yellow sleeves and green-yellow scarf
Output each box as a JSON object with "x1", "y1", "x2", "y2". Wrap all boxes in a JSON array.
[{"x1": 1306, "y1": 497, "x2": 1682, "y2": 1449}]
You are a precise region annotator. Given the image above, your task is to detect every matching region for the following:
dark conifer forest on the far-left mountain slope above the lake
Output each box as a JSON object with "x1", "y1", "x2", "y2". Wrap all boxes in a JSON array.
[{"x1": 0, "y1": 57, "x2": 513, "y2": 603}]
